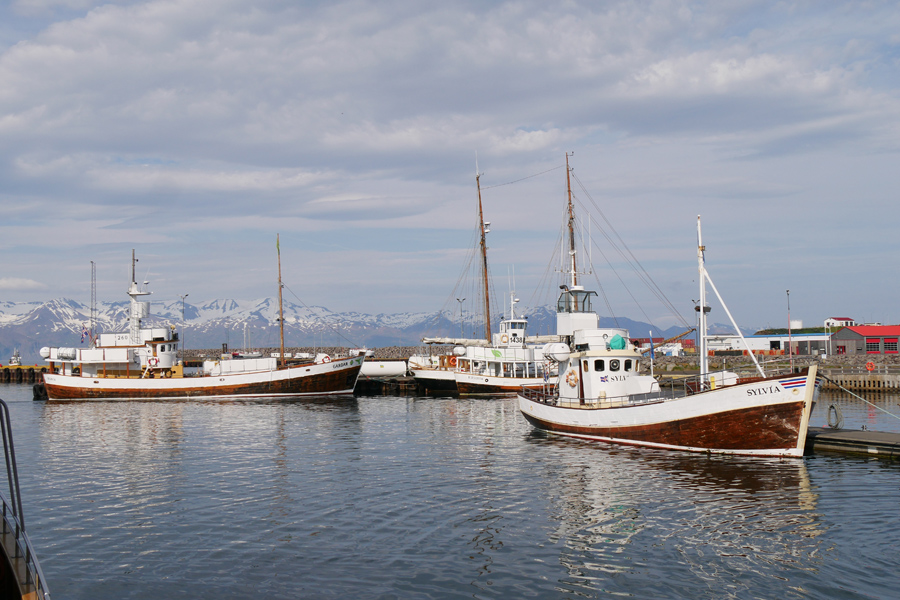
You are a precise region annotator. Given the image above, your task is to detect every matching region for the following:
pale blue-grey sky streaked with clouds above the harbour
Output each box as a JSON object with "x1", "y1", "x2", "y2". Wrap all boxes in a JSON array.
[{"x1": 0, "y1": 0, "x2": 900, "y2": 327}]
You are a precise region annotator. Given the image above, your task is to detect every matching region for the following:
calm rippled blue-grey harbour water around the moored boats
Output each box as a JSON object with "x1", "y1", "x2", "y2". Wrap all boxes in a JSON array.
[{"x1": 0, "y1": 385, "x2": 900, "y2": 599}]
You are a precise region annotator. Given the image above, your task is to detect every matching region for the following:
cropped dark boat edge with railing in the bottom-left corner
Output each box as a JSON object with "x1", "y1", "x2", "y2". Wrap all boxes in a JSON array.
[{"x1": 0, "y1": 400, "x2": 50, "y2": 600}]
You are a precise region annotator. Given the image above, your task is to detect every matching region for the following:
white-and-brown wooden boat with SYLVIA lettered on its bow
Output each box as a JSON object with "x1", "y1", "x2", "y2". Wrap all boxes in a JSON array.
[{"x1": 518, "y1": 157, "x2": 819, "y2": 457}]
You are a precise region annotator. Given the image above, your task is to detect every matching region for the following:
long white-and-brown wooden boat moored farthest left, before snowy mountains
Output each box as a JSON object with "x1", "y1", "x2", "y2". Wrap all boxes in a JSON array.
[{"x1": 35, "y1": 241, "x2": 364, "y2": 401}]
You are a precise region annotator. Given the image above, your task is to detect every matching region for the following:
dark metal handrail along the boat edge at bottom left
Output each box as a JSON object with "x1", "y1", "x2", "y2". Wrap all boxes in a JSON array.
[{"x1": 0, "y1": 398, "x2": 50, "y2": 600}]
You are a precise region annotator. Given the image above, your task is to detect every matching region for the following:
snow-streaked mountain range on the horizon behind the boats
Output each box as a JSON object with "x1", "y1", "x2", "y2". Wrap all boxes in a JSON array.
[{"x1": 0, "y1": 298, "x2": 733, "y2": 364}]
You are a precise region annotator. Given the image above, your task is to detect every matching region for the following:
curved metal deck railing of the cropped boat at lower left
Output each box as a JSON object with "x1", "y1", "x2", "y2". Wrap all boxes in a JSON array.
[{"x1": 0, "y1": 399, "x2": 50, "y2": 600}]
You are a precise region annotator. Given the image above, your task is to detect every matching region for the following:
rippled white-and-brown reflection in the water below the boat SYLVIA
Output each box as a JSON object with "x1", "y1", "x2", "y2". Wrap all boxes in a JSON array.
[{"x1": 529, "y1": 433, "x2": 826, "y2": 597}]
